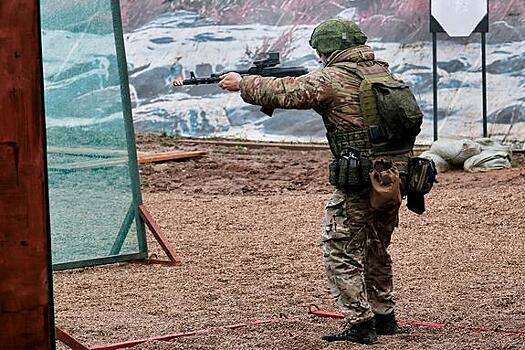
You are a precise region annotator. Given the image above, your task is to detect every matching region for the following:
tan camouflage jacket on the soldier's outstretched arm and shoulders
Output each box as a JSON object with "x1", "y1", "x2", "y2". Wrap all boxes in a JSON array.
[{"x1": 241, "y1": 45, "x2": 388, "y2": 132}]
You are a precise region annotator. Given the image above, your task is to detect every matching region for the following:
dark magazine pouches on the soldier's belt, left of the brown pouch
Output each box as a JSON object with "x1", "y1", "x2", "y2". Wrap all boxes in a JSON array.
[{"x1": 328, "y1": 147, "x2": 371, "y2": 189}]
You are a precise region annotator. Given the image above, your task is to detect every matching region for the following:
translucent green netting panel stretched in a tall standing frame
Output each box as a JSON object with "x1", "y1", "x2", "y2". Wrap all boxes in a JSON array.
[{"x1": 41, "y1": 0, "x2": 146, "y2": 266}]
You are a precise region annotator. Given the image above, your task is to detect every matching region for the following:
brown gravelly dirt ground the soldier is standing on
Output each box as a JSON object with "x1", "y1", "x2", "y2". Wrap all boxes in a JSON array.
[{"x1": 54, "y1": 136, "x2": 525, "y2": 350}]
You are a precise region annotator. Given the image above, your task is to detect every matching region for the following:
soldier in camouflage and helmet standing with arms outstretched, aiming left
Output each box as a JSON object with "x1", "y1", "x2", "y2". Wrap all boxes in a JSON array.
[{"x1": 219, "y1": 20, "x2": 422, "y2": 344}]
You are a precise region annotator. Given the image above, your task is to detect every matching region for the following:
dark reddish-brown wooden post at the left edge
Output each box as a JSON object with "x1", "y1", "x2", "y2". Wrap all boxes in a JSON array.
[{"x1": 0, "y1": 0, "x2": 55, "y2": 350}]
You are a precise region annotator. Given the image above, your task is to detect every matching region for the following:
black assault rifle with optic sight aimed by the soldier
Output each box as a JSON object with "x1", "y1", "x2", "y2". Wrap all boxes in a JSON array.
[{"x1": 176, "y1": 52, "x2": 308, "y2": 85}]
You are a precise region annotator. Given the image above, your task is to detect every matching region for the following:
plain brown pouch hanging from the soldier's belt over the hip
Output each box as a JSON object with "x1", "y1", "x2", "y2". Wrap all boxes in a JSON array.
[{"x1": 370, "y1": 160, "x2": 402, "y2": 211}]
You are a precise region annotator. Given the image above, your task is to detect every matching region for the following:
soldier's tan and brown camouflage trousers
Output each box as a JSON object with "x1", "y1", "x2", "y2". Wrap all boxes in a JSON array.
[{"x1": 322, "y1": 188, "x2": 399, "y2": 324}]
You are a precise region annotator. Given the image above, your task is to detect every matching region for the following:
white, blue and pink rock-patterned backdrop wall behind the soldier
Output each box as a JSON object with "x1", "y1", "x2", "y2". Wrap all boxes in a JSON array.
[{"x1": 122, "y1": 0, "x2": 525, "y2": 148}]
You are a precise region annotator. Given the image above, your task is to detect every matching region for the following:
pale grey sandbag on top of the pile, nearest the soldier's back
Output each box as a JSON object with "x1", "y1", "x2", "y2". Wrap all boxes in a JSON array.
[{"x1": 430, "y1": 139, "x2": 481, "y2": 166}]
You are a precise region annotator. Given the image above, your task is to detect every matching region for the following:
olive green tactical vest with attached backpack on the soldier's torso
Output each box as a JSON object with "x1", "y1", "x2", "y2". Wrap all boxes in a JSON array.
[{"x1": 327, "y1": 62, "x2": 423, "y2": 157}]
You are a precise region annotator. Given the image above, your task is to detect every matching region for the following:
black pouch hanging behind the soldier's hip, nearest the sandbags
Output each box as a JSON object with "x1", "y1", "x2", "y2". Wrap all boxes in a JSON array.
[{"x1": 407, "y1": 157, "x2": 437, "y2": 214}]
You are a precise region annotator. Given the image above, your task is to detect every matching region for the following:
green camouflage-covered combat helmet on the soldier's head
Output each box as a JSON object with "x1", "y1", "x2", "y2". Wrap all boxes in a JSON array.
[{"x1": 310, "y1": 19, "x2": 368, "y2": 54}]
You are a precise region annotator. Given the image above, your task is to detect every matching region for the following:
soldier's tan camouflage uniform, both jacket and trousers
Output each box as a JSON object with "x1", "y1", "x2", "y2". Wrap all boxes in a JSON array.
[{"x1": 241, "y1": 45, "x2": 406, "y2": 324}]
